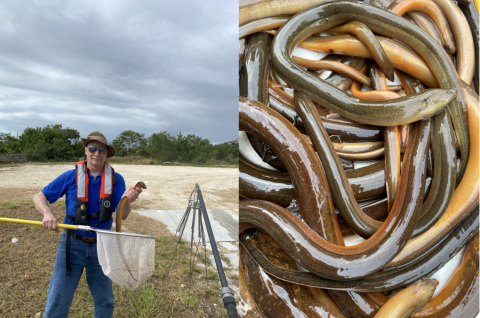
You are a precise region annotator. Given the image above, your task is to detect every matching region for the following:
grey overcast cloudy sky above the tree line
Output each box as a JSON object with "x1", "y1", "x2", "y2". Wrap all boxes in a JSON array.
[{"x1": 0, "y1": 0, "x2": 238, "y2": 143}]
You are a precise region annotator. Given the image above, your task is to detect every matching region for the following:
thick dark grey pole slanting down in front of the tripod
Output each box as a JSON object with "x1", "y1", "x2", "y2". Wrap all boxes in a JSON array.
[{"x1": 195, "y1": 184, "x2": 238, "y2": 318}]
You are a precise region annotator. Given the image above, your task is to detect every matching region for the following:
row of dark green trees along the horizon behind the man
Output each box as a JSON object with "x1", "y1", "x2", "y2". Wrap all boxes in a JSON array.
[{"x1": 0, "y1": 125, "x2": 238, "y2": 165}]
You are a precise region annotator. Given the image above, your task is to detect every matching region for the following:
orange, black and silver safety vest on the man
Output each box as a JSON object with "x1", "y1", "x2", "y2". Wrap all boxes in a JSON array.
[{"x1": 71, "y1": 160, "x2": 115, "y2": 225}]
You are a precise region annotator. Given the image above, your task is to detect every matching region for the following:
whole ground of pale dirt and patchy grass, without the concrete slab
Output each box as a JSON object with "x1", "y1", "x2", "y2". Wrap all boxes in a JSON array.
[{"x1": 0, "y1": 164, "x2": 238, "y2": 317}]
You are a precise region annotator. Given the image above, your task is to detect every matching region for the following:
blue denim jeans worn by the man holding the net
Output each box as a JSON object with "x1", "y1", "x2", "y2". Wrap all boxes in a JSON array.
[{"x1": 43, "y1": 231, "x2": 114, "y2": 318}]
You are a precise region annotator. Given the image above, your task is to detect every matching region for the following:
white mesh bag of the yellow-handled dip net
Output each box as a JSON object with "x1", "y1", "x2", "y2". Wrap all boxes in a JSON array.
[{"x1": 97, "y1": 232, "x2": 155, "y2": 291}]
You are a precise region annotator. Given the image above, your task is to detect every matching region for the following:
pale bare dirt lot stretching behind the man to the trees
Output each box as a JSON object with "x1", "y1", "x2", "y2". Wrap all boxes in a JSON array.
[{"x1": 0, "y1": 163, "x2": 238, "y2": 215}]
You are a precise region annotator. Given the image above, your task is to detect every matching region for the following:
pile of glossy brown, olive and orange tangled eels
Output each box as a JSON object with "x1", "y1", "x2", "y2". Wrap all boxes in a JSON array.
[{"x1": 239, "y1": 0, "x2": 480, "y2": 318}]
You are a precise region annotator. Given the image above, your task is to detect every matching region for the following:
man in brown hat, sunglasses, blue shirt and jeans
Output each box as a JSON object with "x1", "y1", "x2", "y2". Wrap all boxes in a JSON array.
[{"x1": 33, "y1": 131, "x2": 142, "y2": 318}]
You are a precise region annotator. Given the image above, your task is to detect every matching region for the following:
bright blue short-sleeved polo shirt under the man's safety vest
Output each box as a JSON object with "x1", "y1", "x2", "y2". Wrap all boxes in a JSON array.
[{"x1": 42, "y1": 169, "x2": 125, "y2": 237}]
